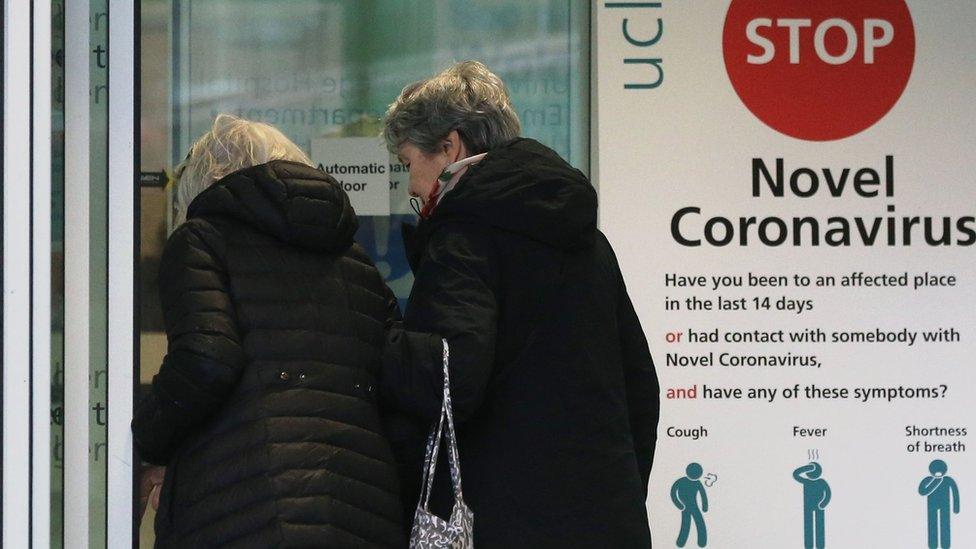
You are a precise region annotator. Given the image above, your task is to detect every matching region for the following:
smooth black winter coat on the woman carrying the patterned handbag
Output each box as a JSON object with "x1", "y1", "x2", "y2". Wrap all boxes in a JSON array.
[{"x1": 381, "y1": 139, "x2": 659, "y2": 549}]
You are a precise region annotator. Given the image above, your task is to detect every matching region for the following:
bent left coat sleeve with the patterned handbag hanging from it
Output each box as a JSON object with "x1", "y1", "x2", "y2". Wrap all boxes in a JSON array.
[{"x1": 380, "y1": 224, "x2": 498, "y2": 423}]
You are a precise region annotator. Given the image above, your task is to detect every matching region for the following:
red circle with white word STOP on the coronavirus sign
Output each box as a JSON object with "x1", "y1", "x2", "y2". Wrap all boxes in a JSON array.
[{"x1": 722, "y1": 0, "x2": 915, "y2": 141}]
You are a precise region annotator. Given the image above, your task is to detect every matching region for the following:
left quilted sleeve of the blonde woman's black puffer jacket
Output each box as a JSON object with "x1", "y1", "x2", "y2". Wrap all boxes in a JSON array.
[{"x1": 132, "y1": 220, "x2": 245, "y2": 464}]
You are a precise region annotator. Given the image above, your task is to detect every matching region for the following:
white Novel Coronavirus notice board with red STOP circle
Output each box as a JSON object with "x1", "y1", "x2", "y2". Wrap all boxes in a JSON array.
[{"x1": 594, "y1": 0, "x2": 976, "y2": 548}]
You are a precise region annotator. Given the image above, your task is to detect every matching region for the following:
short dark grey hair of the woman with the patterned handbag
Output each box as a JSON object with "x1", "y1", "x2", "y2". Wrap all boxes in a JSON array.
[{"x1": 383, "y1": 61, "x2": 522, "y2": 154}]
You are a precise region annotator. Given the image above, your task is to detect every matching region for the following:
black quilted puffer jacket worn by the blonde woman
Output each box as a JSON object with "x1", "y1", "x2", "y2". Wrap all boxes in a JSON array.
[{"x1": 132, "y1": 161, "x2": 405, "y2": 548}]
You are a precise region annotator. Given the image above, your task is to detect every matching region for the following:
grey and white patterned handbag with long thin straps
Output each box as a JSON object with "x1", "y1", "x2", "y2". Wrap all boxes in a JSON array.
[{"x1": 410, "y1": 339, "x2": 474, "y2": 549}]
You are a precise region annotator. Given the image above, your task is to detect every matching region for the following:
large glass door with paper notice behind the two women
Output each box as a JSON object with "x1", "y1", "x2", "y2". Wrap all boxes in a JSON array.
[{"x1": 139, "y1": 0, "x2": 590, "y2": 546}]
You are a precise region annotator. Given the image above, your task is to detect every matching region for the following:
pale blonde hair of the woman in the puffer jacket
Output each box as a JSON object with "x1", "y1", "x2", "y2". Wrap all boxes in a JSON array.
[{"x1": 174, "y1": 114, "x2": 313, "y2": 225}]
